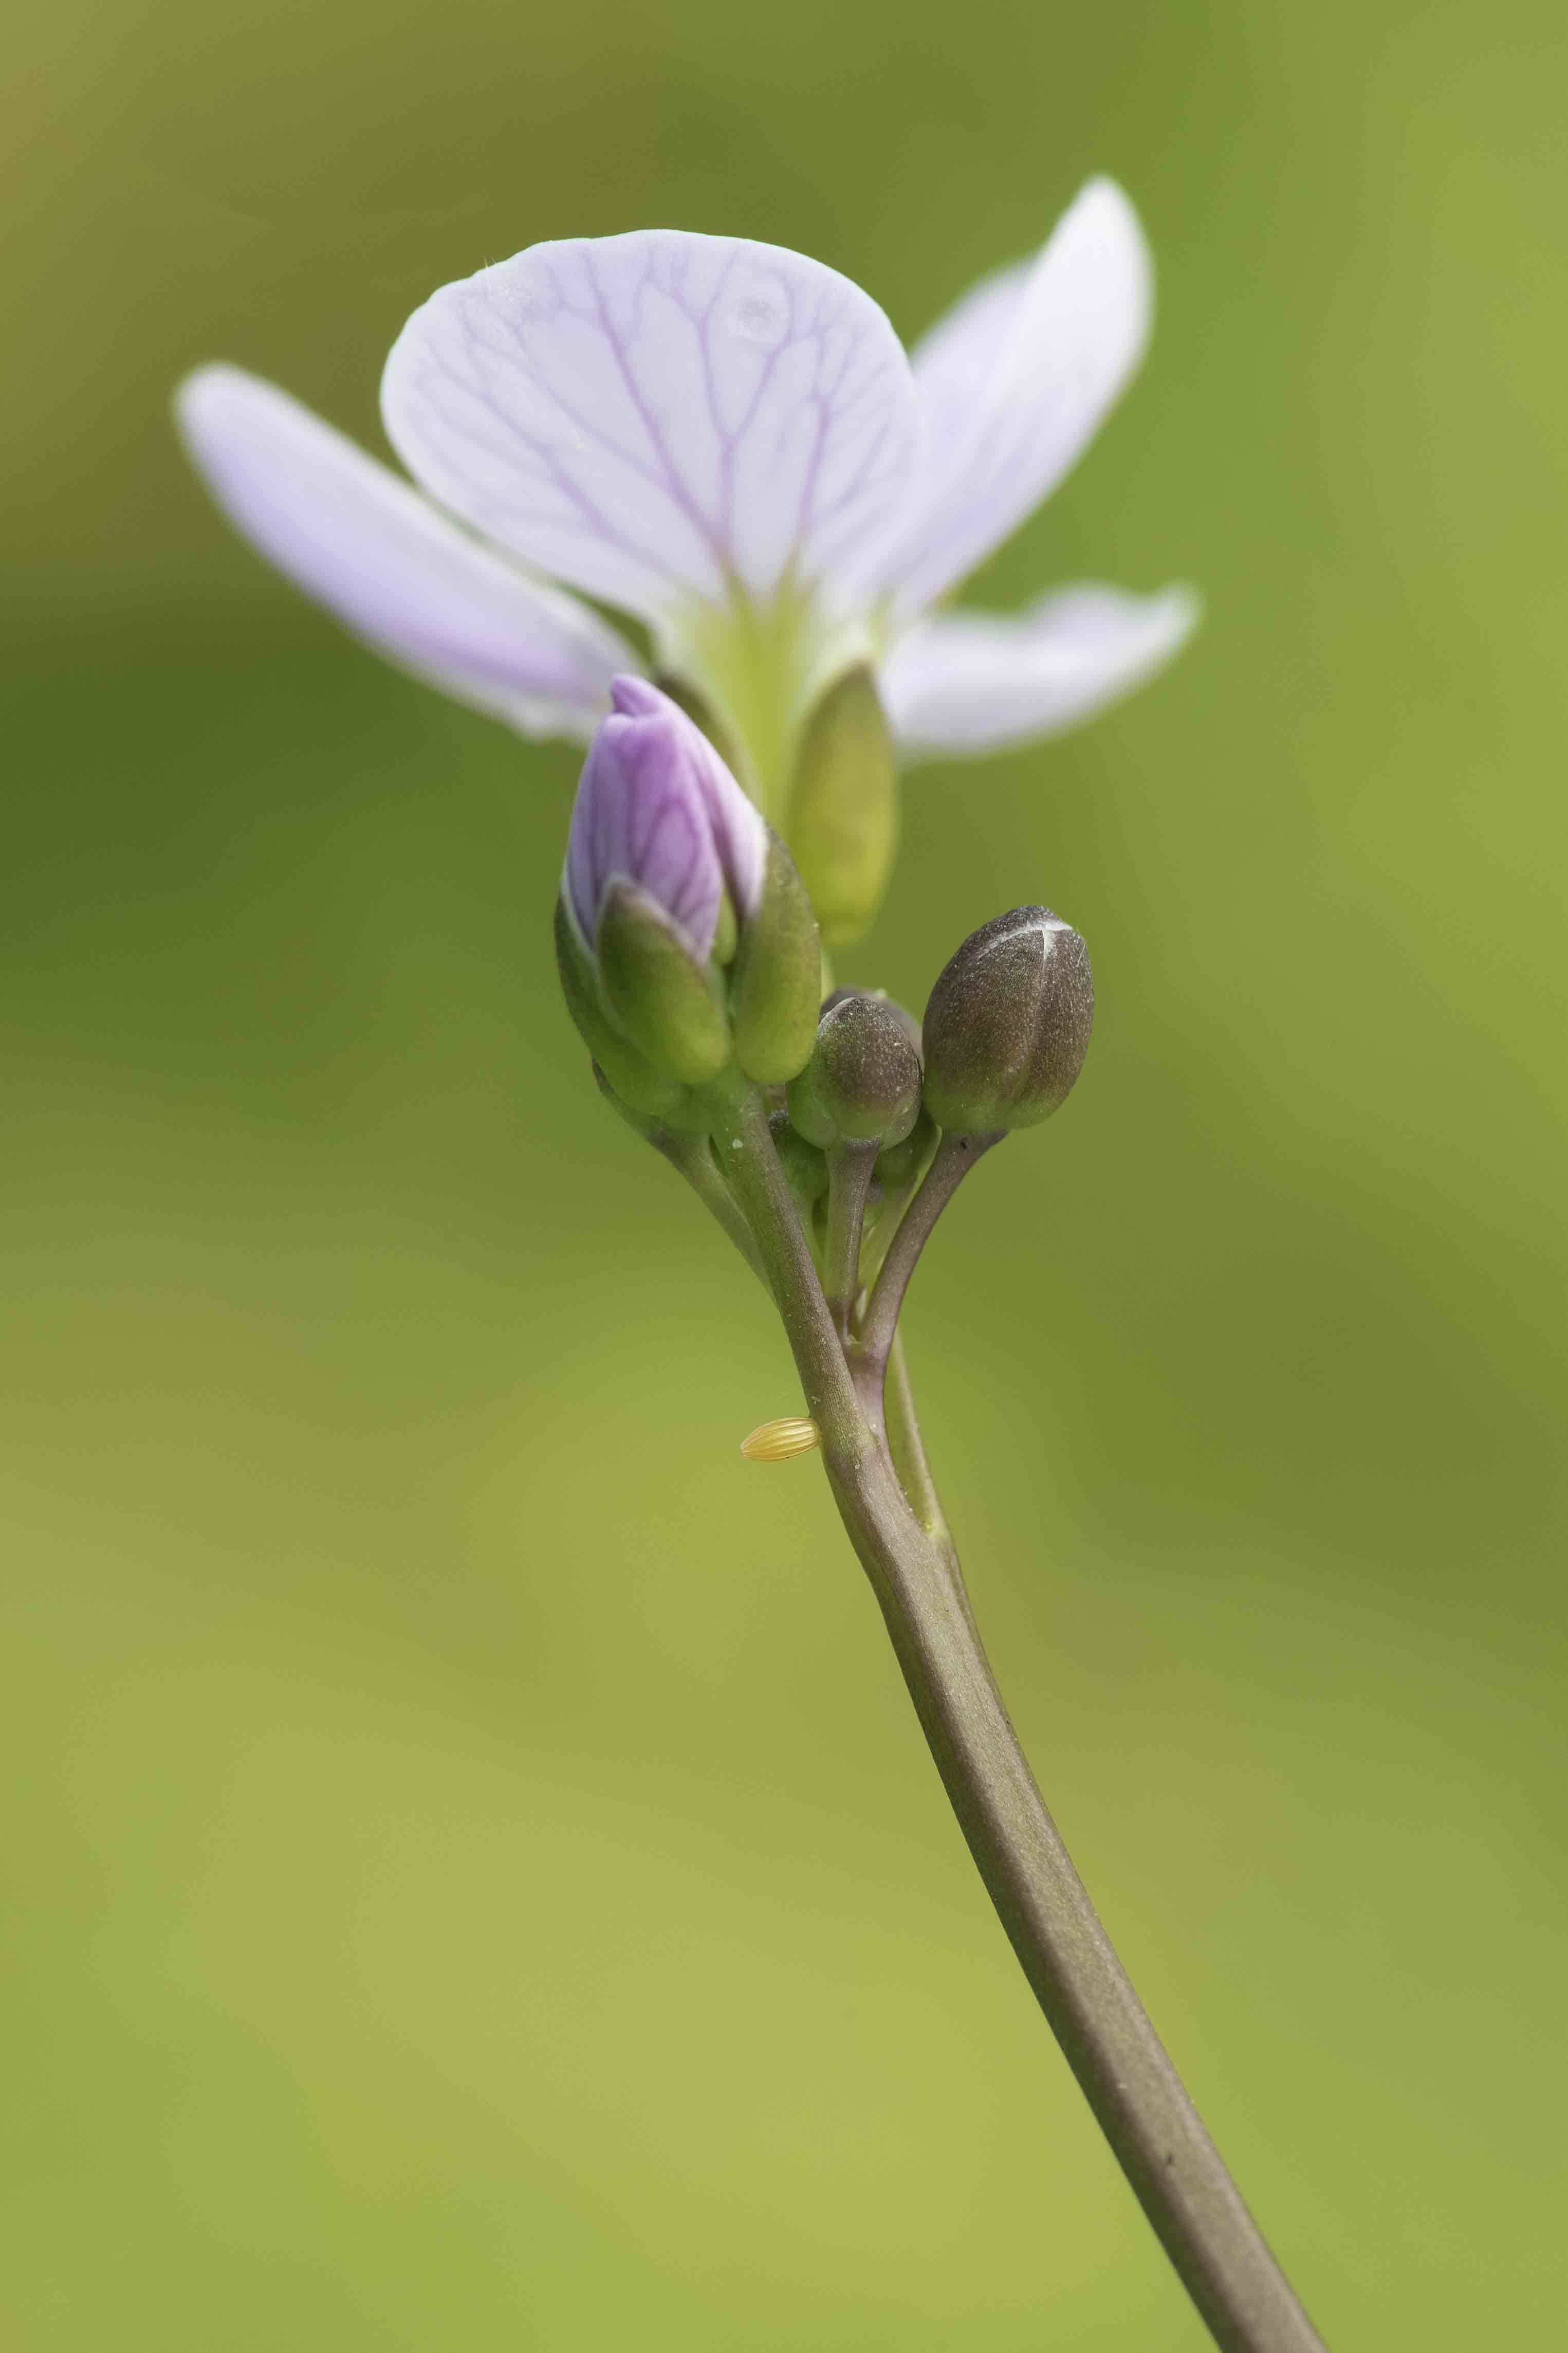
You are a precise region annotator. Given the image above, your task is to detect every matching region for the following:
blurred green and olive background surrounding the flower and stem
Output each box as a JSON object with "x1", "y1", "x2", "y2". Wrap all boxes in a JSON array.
[{"x1": 0, "y1": 0, "x2": 1568, "y2": 2353}]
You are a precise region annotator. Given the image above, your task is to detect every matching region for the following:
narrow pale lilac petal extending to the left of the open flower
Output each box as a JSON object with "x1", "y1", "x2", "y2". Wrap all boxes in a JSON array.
[{"x1": 176, "y1": 367, "x2": 635, "y2": 737}]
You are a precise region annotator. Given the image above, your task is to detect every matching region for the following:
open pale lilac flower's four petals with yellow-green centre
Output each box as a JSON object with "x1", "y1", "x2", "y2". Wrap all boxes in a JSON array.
[{"x1": 179, "y1": 179, "x2": 1196, "y2": 814}]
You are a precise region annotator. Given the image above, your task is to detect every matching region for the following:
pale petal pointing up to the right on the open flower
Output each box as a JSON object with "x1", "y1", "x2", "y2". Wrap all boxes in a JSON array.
[{"x1": 889, "y1": 179, "x2": 1152, "y2": 614}]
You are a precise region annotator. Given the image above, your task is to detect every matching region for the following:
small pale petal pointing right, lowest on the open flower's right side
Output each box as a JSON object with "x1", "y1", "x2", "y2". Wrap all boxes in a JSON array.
[{"x1": 881, "y1": 583, "x2": 1199, "y2": 758}]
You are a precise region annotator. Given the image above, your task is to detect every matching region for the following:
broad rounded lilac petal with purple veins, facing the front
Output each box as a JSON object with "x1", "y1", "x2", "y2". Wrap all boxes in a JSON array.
[{"x1": 381, "y1": 228, "x2": 919, "y2": 621}]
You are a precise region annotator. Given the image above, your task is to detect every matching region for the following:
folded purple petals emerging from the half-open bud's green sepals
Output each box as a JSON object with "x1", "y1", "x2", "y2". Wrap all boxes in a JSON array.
[{"x1": 566, "y1": 678, "x2": 769, "y2": 965}]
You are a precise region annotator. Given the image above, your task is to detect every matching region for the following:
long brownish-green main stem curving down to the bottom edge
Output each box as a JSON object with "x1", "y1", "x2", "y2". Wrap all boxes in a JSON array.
[{"x1": 715, "y1": 1092, "x2": 1323, "y2": 2353}]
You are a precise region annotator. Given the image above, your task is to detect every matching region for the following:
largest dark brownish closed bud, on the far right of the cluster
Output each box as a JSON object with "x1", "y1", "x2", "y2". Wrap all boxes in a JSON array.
[{"x1": 924, "y1": 906, "x2": 1096, "y2": 1134}]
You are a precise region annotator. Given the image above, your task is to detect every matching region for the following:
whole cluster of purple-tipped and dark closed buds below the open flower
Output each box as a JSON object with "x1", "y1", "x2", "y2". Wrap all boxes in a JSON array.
[{"x1": 557, "y1": 678, "x2": 1093, "y2": 1351}]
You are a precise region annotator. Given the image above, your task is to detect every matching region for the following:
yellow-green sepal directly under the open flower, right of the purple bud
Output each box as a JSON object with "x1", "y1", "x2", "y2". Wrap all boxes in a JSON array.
[{"x1": 785, "y1": 668, "x2": 898, "y2": 949}]
